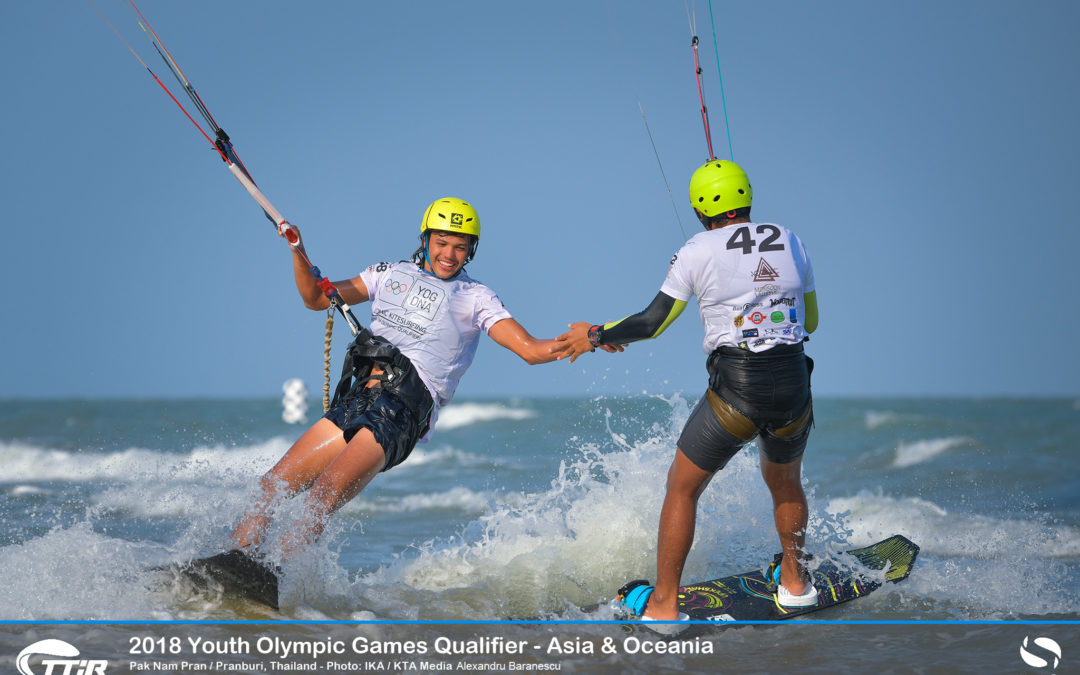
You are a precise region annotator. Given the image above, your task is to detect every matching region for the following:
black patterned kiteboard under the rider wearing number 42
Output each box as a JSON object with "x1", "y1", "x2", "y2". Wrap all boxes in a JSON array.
[{"x1": 617, "y1": 535, "x2": 919, "y2": 622}]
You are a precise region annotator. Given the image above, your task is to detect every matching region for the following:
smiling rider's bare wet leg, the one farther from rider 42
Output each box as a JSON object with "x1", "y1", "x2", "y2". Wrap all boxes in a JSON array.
[{"x1": 232, "y1": 419, "x2": 346, "y2": 549}]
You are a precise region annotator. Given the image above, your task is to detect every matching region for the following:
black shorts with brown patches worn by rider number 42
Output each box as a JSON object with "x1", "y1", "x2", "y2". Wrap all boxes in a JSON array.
[{"x1": 678, "y1": 345, "x2": 813, "y2": 472}]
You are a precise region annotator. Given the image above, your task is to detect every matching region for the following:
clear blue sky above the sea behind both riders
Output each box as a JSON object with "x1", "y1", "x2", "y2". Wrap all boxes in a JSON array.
[{"x1": 0, "y1": 0, "x2": 1080, "y2": 399}]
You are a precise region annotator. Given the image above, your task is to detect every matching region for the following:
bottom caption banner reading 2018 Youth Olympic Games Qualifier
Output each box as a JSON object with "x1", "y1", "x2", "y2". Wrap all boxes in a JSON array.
[{"x1": 0, "y1": 621, "x2": 1080, "y2": 675}]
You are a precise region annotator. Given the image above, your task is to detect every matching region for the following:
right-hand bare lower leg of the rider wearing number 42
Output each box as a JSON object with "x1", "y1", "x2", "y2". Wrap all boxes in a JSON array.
[{"x1": 760, "y1": 455, "x2": 810, "y2": 595}]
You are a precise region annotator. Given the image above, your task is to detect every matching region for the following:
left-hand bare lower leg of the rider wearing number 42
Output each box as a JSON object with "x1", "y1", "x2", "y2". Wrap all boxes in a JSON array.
[{"x1": 646, "y1": 449, "x2": 713, "y2": 620}]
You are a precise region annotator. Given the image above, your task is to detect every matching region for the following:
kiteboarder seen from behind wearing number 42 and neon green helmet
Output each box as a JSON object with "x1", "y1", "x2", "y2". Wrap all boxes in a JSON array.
[{"x1": 556, "y1": 159, "x2": 818, "y2": 620}]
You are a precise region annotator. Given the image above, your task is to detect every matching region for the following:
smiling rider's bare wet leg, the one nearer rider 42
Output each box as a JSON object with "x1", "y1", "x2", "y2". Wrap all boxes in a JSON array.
[{"x1": 282, "y1": 429, "x2": 387, "y2": 559}]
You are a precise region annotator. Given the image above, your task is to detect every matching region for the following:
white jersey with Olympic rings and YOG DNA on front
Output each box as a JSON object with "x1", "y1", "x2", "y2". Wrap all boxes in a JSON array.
[{"x1": 360, "y1": 262, "x2": 511, "y2": 419}]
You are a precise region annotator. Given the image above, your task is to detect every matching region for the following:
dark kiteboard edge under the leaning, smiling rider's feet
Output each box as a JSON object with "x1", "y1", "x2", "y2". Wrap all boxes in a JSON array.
[{"x1": 160, "y1": 550, "x2": 279, "y2": 610}]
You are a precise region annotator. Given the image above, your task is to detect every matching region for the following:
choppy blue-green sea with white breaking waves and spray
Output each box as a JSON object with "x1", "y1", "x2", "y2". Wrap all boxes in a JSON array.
[{"x1": 0, "y1": 395, "x2": 1080, "y2": 672}]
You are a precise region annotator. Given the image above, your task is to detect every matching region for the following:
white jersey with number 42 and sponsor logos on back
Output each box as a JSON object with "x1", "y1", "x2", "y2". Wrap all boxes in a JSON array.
[{"x1": 660, "y1": 222, "x2": 814, "y2": 354}]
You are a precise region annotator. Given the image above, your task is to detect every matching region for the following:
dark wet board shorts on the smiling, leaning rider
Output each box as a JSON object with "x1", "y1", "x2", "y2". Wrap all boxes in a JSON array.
[{"x1": 323, "y1": 372, "x2": 432, "y2": 471}]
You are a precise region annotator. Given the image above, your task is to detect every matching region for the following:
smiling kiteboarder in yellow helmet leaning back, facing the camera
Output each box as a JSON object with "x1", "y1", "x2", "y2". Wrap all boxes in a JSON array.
[{"x1": 215, "y1": 197, "x2": 617, "y2": 597}]
